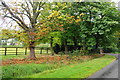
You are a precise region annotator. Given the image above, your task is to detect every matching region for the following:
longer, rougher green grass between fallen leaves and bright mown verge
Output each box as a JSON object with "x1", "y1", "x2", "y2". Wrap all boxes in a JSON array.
[{"x1": 2, "y1": 63, "x2": 56, "y2": 78}]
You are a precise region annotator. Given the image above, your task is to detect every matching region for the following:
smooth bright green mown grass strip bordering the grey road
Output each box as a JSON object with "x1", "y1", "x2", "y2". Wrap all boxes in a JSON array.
[{"x1": 24, "y1": 55, "x2": 115, "y2": 78}]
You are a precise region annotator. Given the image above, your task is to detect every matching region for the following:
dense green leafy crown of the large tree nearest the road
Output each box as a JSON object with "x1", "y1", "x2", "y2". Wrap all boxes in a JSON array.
[{"x1": 73, "y1": 2, "x2": 119, "y2": 52}]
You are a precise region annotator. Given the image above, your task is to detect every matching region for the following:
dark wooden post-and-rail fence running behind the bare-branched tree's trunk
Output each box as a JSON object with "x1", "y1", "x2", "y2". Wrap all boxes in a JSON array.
[{"x1": 0, "y1": 47, "x2": 50, "y2": 56}]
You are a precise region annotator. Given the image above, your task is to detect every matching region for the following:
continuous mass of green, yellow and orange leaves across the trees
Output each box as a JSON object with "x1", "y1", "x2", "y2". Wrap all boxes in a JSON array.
[{"x1": 1, "y1": 1, "x2": 120, "y2": 52}]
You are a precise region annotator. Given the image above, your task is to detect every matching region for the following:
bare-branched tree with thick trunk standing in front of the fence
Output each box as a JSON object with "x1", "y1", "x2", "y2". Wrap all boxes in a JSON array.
[{"x1": 1, "y1": 0, "x2": 45, "y2": 59}]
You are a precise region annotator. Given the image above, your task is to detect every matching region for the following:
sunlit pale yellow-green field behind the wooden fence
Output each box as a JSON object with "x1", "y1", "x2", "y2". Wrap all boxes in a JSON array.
[{"x1": 0, "y1": 43, "x2": 51, "y2": 55}]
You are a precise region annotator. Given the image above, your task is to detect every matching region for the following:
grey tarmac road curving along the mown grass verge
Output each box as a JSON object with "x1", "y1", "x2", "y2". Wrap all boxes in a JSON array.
[{"x1": 85, "y1": 53, "x2": 120, "y2": 80}]
